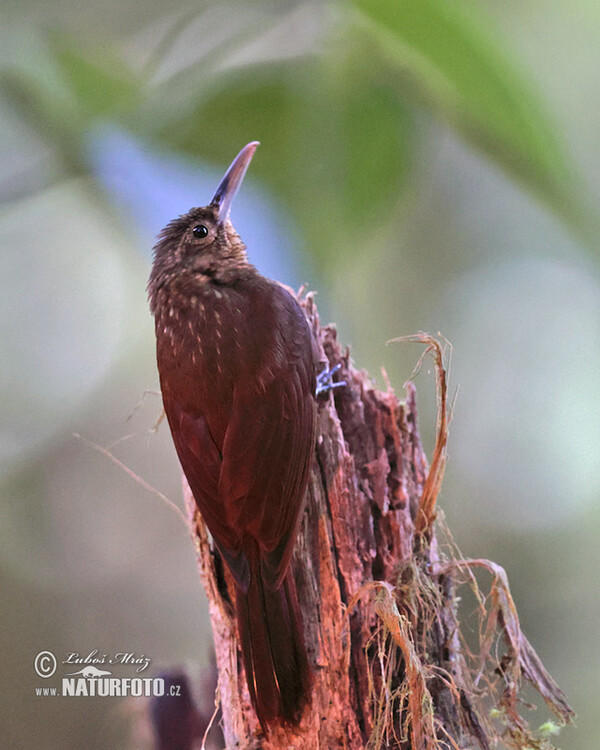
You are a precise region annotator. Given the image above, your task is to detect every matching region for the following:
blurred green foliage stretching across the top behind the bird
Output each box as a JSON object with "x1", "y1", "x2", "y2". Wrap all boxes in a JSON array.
[{"x1": 3, "y1": 0, "x2": 581, "y2": 270}]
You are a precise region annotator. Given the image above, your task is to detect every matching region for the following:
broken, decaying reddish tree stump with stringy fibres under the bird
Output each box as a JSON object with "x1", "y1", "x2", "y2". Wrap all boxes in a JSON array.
[{"x1": 184, "y1": 295, "x2": 573, "y2": 750}]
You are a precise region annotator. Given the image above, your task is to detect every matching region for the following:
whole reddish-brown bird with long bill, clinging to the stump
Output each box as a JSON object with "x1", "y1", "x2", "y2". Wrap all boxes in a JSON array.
[{"x1": 148, "y1": 141, "x2": 330, "y2": 727}]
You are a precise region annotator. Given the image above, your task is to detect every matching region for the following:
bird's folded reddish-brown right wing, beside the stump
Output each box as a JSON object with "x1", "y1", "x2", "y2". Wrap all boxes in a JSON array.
[{"x1": 218, "y1": 292, "x2": 316, "y2": 584}]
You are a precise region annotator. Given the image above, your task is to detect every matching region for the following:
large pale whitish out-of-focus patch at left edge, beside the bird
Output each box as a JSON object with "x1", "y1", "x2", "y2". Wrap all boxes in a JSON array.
[{"x1": 0, "y1": 180, "x2": 142, "y2": 467}]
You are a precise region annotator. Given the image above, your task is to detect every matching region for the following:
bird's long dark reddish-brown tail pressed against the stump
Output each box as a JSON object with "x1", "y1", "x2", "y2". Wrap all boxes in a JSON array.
[{"x1": 236, "y1": 561, "x2": 310, "y2": 728}]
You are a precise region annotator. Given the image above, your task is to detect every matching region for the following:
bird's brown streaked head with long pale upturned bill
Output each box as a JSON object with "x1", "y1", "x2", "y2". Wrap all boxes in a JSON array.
[{"x1": 148, "y1": 141, "x2": 258, "y2": 292}]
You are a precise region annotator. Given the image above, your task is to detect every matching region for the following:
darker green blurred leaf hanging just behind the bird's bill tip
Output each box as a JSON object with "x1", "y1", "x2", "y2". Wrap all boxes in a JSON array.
[{"x1": 150, "y1": 55, "x2": 410, "y2": 274}]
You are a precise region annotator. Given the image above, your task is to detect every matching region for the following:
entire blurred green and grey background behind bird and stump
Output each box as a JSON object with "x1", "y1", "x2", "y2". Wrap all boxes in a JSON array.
[{"x1": 0, "y1": 0, "x2": 600, "y2": 750}]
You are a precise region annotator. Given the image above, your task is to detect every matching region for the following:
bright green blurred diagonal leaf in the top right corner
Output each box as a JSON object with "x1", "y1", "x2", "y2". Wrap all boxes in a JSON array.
[{"x1": 352, "y1": 0, "x2": 575, "y2": 225}]
